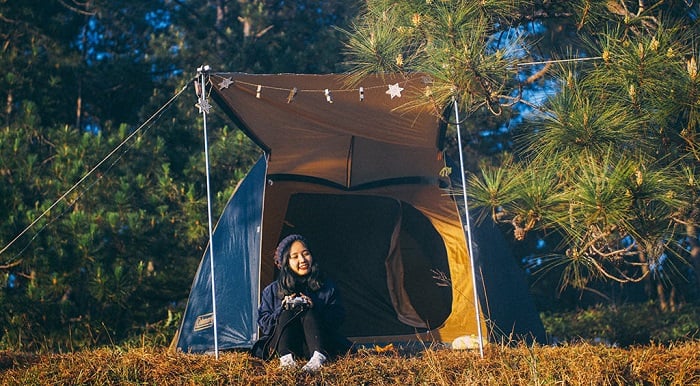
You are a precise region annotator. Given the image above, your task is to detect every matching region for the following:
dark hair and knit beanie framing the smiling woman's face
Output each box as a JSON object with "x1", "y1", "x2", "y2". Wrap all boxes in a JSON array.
[{"x1": 275, "y1": 234, "x2": 323, "y2": 297}]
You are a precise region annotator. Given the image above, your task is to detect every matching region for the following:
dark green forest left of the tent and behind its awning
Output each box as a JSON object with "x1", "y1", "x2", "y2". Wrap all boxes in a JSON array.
[{"x1": 0, "y1": 0, "x2": 355, "y2": 351}]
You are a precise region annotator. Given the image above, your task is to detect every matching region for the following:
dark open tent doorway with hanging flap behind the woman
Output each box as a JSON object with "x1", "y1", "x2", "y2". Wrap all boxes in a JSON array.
[{"x1": 281, "y1": 193, "x2": 452, "y2": 337}]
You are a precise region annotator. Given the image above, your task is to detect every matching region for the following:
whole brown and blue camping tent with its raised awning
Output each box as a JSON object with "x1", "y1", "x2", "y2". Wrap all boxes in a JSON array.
[{"x1": 175, "y1": 73, "x2": 545, "y2": 352}]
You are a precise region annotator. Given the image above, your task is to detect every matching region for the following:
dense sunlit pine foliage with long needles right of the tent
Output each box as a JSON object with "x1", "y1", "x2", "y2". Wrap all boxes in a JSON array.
[{"x1": 472, "y1": 4, "x2": 700, "y2": 308}]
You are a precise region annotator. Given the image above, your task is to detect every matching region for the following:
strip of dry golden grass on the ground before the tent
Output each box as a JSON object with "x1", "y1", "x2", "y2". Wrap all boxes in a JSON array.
[{"x1": 0, "y1": 342, "x2": 700, "y2": 385}]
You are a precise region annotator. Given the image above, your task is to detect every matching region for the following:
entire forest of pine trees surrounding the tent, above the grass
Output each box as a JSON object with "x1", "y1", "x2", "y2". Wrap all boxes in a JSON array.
[{"x1": 0, "y1": 0, "x2": 700, "y2": 351}]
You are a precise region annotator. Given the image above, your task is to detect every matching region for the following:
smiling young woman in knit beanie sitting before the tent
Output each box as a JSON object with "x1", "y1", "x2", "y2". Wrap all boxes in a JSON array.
[{"x1": 254, "y1": 234, "x2": 351, "y2": 372}]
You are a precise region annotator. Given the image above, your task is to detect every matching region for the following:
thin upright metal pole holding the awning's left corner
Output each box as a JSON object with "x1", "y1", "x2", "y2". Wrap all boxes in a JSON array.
[{"x1": 197, "y1": 66, "x2": 219, "y2": 360}]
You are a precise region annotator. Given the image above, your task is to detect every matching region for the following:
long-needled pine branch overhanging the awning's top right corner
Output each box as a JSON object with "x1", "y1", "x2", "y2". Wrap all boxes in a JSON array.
[{"x1": 346, "y1": 0, "x2": 530, "y2": 114}]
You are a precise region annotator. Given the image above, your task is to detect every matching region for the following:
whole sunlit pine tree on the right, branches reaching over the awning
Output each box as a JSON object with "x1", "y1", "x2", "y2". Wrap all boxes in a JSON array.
[{"x1": 347, "y1": 0, "x2": 700, "y2": 309}]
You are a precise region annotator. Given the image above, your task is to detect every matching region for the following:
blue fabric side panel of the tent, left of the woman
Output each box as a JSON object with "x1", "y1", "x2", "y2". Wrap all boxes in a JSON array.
[{"x1": 177, "y1": 156, "x2": 267, "y2": 352}]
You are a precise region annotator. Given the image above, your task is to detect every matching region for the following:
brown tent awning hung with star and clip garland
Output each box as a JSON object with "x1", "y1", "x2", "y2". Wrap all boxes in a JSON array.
[{"x1": 210, "y1": 73, "x2": 444, "y2": 189}]
